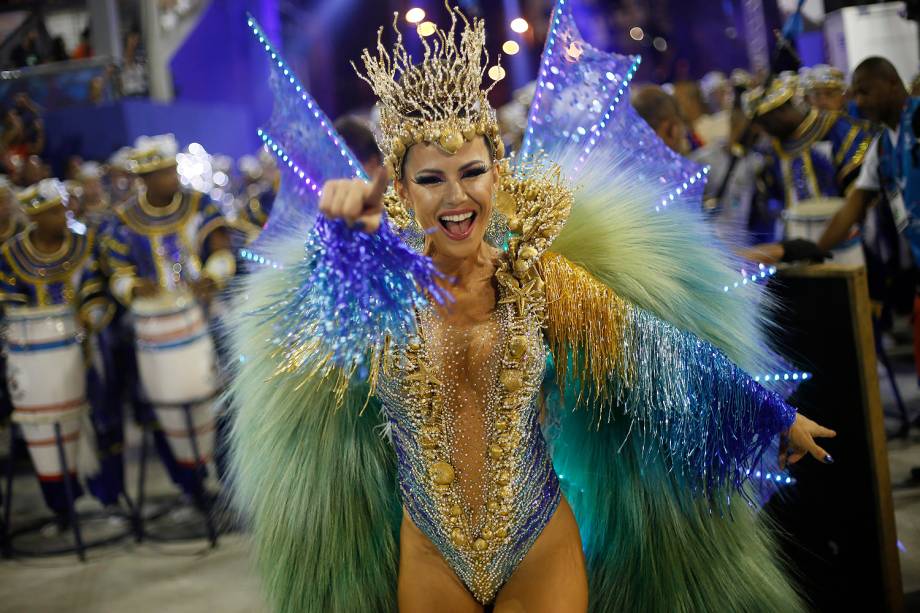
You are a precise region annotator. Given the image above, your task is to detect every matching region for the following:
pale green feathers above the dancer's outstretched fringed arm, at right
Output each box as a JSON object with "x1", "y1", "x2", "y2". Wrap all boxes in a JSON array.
[{"x1": 550, "y1": 151, "x2": 782, "y2": 375}]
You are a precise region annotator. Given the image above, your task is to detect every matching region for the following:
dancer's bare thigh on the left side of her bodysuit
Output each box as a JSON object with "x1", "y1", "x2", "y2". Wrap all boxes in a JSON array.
[{"x1": 397, "y1": 512, "x2": 482, "y2": 613}]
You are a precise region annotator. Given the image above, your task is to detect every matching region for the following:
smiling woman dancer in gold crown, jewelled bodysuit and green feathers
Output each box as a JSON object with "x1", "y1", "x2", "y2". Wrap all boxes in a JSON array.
[{"x1": 232, "y1": 3, "x2": 833, "y2": 612}]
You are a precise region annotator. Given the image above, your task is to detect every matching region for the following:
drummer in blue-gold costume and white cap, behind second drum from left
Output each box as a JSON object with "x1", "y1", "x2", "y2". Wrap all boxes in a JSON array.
[{"x1": 106, "y1": 134, "x2": 236, "y2": 496}]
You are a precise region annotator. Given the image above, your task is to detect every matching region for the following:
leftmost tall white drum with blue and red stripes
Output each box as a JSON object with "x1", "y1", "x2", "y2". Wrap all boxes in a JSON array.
[{"x1": 6, "y1": 306, "x2": 88, "y2": 481}]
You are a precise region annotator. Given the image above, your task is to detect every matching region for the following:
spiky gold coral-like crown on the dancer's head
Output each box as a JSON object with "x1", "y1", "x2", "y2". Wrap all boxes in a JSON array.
[{"x1": 352, "y1": 6, "x2": 504, "y2": 178}]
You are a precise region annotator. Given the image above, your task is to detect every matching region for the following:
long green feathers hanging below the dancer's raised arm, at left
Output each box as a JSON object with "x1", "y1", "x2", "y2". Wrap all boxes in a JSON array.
[{"x1": 228, "y1": 233, "x2": 402, "y2": 613}]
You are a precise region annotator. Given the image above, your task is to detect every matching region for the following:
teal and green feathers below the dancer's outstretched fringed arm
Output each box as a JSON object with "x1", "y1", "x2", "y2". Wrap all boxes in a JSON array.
[{"x1": 546, "y1": 376, "x2": 805, "y2": 613}]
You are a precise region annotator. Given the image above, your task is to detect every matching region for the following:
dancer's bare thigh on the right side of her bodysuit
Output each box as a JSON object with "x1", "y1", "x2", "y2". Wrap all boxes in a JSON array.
[{"x1": 494, "y1": 498, "x2": 588, "y2": 613}]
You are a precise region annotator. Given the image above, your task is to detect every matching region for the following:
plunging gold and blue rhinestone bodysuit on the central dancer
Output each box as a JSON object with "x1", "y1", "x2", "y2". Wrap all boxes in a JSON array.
[{"x1": 378, "y1": 264, "x2": 560, "y2": 603}]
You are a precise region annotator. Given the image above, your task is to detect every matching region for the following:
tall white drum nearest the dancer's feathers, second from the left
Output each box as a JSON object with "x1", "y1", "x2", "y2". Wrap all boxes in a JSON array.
[{"x1": 131, "y1": 293, "x2": 219, "y2": 466}]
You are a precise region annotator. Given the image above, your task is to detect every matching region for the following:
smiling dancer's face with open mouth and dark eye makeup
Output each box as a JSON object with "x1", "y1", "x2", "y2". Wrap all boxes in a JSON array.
[{"x1": 396, "y1": 137, "x2": 498, "y2": 259}]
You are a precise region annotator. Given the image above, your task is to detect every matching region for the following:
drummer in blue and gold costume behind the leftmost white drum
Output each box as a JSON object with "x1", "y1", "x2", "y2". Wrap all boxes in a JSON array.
[{"x1": 0, "y1": 179, "x2": 124, "y2": 513}]
